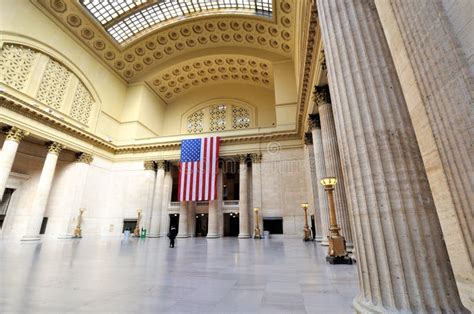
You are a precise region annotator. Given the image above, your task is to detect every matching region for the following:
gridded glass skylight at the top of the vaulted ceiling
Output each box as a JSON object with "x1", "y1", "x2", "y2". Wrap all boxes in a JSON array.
[{"x1": 80, "y1": 0, "x2": 273, "y2": 43}]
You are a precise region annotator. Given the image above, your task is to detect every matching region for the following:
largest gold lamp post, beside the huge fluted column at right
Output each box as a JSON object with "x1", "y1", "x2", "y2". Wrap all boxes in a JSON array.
[{"x1": 320, "y1": 177, "x2": 352, "y2": 264}]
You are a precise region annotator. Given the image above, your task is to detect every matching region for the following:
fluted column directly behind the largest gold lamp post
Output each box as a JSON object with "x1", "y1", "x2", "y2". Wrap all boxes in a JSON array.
[{"x1": 314, "y1": 86, "x2": 354, "y2": 251}]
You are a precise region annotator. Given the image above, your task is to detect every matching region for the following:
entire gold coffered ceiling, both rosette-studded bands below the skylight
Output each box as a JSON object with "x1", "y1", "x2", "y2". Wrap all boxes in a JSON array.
[{"x1": 32, "y1": 0, "x2": 296, "y2": 84}]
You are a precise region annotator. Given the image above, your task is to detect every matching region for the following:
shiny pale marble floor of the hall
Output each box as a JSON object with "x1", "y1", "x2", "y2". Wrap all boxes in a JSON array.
[{"x1": 0, "y1": 238, "x2": 358, "y2": 313}]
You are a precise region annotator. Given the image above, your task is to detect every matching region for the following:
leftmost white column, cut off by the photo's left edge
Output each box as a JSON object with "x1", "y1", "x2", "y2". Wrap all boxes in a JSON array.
[{"x1": 0, "y1": 127, "x2": 29, "y2": 201}]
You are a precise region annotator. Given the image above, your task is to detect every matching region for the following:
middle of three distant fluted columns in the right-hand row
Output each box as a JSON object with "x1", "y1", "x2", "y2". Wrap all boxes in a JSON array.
[{"x1": 309, "y1": 114, "x2": 329, "y2": 245}]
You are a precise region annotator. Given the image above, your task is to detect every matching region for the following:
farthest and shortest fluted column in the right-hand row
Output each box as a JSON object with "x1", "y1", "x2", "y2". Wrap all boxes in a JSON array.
[{"x1": 305, "y1": 133, "x2": 323, "y2": 242}]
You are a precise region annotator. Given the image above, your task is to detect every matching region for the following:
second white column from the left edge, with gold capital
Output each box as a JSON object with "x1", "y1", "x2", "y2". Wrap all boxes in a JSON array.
[{"x1": 21, "y1": 143, "x2": 64, "y2": 241}]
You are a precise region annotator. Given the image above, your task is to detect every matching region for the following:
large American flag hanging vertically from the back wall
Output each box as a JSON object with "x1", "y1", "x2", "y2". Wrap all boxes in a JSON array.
[{"x1": 178, "y1": 136, "x2": 220, "y2": 202}]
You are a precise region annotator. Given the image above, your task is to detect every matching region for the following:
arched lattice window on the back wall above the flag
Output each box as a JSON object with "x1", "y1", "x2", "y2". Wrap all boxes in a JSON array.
[{"x1": 184, "y1": 101, "x2": 254, "y2": 133}]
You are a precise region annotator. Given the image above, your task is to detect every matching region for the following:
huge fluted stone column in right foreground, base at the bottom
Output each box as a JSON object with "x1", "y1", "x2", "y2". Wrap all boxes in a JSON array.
[{"x1": 317, "y1": 0, "x2": 465, "y2": 313}]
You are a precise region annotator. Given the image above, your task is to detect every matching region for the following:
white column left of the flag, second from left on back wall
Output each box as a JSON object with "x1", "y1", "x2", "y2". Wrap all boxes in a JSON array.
[{"x1": 148, "y1": 160, "x2": 165, "y2": 238}]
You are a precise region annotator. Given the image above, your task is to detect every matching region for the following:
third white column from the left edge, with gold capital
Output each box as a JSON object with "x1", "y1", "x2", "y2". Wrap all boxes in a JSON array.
[{"x1": 58, "y1": 153, "x2": 94, "y2": 239}]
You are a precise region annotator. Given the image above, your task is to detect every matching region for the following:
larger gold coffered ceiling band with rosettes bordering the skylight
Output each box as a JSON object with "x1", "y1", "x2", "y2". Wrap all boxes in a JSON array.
[{"x1": 36, "y1": 0, "x2": 296, "y2": 84}]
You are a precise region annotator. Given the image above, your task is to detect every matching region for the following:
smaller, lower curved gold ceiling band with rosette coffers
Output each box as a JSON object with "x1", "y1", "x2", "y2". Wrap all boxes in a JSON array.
[{"x1": 147, "y1": 54, "x2": 273, "y2": 102}]
